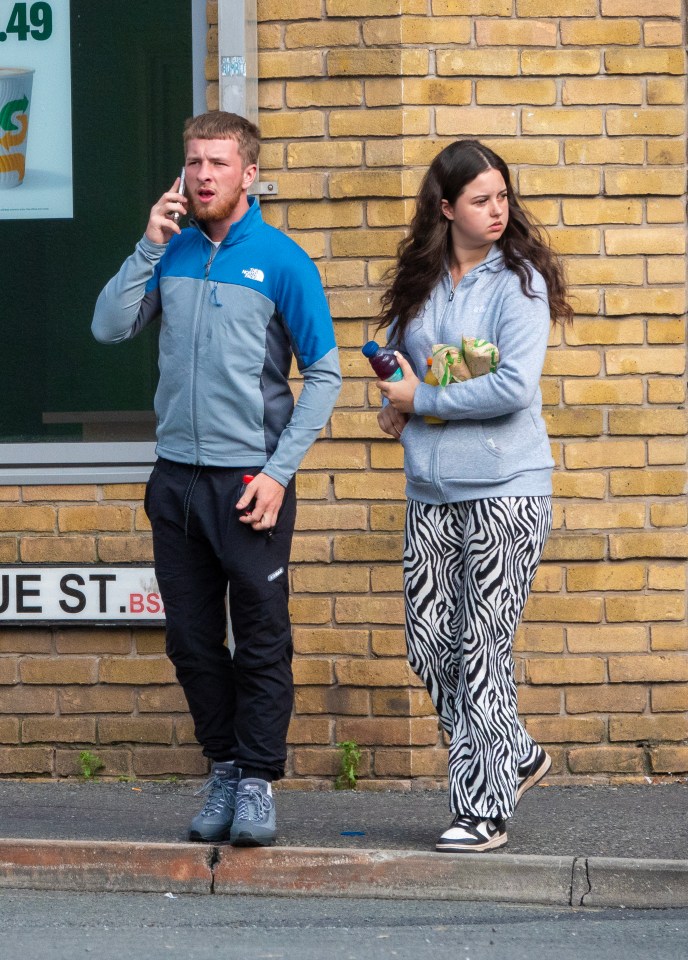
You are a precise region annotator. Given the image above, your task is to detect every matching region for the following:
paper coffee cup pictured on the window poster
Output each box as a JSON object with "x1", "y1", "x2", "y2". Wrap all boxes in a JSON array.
[{"x1": 0, "y1": 67, "x2": 34, "y2": 190}]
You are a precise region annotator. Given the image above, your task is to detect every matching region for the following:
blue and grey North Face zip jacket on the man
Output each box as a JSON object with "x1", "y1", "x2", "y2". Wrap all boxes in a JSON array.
[{"x1": 92, "y1": 198, "x2": 341, "y2": 485}]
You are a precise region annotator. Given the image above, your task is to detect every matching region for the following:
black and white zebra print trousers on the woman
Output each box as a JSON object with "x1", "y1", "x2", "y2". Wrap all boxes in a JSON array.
[{"x1": 404, "y1": 496, "x2": 552, "y2": 818}]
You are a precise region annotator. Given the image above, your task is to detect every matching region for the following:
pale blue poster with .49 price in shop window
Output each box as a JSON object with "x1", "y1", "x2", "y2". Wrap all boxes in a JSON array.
[{"x1": 0, "y1": 0, "x2": 74, "y2": 220}]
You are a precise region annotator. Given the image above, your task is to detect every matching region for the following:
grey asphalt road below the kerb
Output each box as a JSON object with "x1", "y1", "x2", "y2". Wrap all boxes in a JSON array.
[{"x1": 0, "y1": 890, "x2": 688, "y2": 960}]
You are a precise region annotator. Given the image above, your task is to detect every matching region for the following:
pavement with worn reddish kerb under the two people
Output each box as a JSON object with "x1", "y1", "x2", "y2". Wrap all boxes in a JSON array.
[{"x1": 0, "y1": 780, "x2": 688, "y2": 907}]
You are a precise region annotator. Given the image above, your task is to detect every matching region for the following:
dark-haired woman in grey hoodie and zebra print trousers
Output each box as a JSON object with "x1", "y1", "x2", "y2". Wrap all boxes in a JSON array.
[{"x1": 377, "y1": 140, "x2": 572, "y2": 852}]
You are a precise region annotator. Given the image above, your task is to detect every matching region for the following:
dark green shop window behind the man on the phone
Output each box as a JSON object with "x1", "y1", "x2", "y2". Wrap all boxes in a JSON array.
[{"x1": 0, "y1": 0, "x2": 199, "y2": 482}]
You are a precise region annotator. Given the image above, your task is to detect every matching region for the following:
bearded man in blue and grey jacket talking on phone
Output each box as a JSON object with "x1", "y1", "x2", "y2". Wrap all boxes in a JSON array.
[{"x1": 92, "y1": 110, "x2": 341, "y2": 846}]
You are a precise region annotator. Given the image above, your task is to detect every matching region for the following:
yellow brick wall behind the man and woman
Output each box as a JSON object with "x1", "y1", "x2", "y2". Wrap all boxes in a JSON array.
[{"x1": 0, "y1": 0, "x2": 688, "y2": 788}]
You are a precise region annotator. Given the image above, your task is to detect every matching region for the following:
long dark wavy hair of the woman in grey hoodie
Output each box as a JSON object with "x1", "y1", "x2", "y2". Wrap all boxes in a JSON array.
[{"x1": 378, "y1": 140, "x2": 573, "y2": 343}]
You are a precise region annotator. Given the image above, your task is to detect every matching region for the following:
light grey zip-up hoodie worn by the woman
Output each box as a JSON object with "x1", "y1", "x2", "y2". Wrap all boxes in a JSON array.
[{"x1": 390, "y1": 246, "x2": 554, "y2": 503}]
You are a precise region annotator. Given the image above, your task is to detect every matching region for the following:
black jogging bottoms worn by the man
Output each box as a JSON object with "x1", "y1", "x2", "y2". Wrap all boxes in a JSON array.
[{"x1": 145, "y1": 459, "x2": 296, "y2": 780}]
